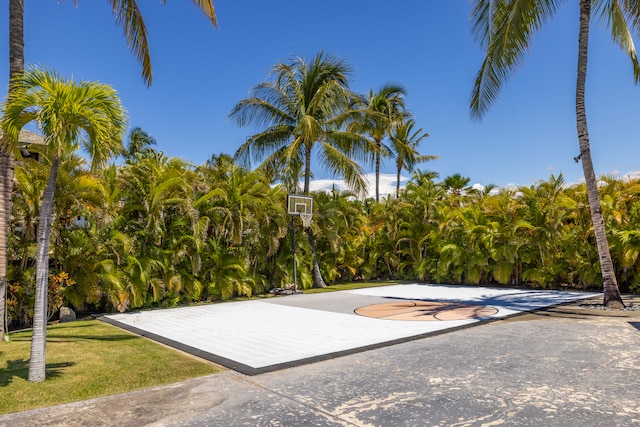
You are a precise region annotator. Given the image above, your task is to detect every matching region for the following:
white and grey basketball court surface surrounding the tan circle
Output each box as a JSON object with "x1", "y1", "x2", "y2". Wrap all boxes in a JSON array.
[{"x1": 103, "y1": 284, "x2": 598, "y2": 374}]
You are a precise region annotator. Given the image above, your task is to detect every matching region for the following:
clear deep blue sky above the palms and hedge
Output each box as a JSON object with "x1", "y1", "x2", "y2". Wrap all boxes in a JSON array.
[{"x1": 0, "y1": 0, "x2": 640, "y2": 195}]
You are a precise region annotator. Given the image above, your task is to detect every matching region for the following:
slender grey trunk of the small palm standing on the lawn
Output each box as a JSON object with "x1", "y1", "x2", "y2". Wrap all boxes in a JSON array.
[{"x1": 29, "y1": 155, "x2": 60, "y2": 382}]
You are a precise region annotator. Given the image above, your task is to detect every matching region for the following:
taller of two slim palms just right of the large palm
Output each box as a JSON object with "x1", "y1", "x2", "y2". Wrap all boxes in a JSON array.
[{"x1": 353, "y1": 83, "x2": 406, "y2": 201}]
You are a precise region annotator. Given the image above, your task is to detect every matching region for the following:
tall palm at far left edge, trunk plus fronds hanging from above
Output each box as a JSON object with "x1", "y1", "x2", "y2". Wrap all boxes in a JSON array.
[{"x1": 0, "y1": 0, "x2": 217, "y2": 342}]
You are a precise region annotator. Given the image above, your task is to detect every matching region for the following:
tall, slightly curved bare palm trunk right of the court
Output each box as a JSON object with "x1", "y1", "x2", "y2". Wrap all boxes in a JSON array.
[{"x1": 576, "y1": 0, "x2": 624, "y2": 308}]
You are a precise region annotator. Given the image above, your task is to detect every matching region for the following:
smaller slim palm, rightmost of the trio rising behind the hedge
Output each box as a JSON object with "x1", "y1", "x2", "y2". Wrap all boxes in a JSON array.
[{"x1": 390, "y1": 119, "x2": 438, "y2": 198}]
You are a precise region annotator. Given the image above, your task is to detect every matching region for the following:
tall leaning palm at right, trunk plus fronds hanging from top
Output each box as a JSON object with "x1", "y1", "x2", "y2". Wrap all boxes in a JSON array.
[{"x1": 471, "y1": 0, "x2": 640, "y2": 308}]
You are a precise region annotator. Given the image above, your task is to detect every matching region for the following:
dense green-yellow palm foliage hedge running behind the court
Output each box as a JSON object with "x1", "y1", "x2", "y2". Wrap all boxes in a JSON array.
[{"x1": 8, "y1": 147, "x2": 640, "y2": 327}]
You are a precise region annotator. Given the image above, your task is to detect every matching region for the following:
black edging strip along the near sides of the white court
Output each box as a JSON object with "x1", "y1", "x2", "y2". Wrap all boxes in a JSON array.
[{"x1": 98, "y1": 301, "x2": 596, "y2": 376}]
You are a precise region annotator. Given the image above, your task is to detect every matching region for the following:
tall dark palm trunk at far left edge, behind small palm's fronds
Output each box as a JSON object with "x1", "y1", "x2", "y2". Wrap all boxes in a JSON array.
[{"x1": 0, "y1": 0, "x2": 24, "y2": 337}]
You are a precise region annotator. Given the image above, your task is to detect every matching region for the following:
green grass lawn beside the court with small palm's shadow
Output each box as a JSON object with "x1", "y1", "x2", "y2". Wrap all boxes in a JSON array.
[{"x1": 0, "y1": 320, "x2": 220, "y2": 414}]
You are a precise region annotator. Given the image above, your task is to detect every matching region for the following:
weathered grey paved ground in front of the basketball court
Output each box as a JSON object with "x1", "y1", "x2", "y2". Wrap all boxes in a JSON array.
[{"x1": 0, "y1": 286, "x2": 640, "y2": 427}]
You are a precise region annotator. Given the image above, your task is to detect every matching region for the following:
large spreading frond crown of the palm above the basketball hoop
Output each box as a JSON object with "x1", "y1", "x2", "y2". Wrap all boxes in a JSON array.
[{"x1": 229, "y1": 52, "x2": 367, "y2": 195}]
